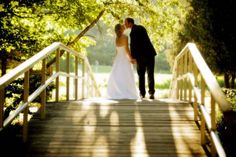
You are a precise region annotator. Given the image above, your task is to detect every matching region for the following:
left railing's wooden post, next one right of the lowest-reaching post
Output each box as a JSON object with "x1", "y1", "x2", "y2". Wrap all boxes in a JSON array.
[{"x1": 40, "y1": 59, "x2": 46, "y2": 119}]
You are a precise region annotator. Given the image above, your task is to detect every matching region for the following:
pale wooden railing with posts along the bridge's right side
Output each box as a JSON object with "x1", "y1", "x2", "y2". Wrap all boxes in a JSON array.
[{"x1": 170, "y1": 43, "x2": 232, "y2": 157}]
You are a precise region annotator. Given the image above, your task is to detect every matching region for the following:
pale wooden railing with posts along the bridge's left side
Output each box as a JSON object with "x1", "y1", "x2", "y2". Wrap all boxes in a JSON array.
[{"x1": 0, "y1": 42, "x2": 100, "y2": 141}]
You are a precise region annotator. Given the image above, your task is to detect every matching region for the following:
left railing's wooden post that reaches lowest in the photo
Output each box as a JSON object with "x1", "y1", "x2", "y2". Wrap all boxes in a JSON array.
[{"x1": 23, "y1": 71, "x2": 29, "y2": 143}]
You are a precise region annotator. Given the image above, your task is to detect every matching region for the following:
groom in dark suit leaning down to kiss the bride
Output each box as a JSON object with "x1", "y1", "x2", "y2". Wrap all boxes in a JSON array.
[{"x1": 125, "y1": 17, "x2": 156, "y2": 99}]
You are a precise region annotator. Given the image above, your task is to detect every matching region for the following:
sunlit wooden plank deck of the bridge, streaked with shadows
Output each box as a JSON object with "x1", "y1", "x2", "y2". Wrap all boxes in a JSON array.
[{"x1": 24, "y1": 99, "x2": 206, "y2": 157}]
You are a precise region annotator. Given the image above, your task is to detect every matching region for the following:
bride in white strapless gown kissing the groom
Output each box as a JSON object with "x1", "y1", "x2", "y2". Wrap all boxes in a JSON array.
[{"x1": 107, "y1": 24, "x2": 138, "y2": 99}]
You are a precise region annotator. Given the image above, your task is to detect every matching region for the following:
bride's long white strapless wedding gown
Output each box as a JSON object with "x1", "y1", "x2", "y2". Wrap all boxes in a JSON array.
[{"x1": 107, "y1": 46, "x2": 138, "y2": 99}]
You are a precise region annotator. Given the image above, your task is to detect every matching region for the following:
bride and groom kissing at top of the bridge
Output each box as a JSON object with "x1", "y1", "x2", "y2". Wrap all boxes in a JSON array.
[{"x1": 107, "y1": 18, "x2": 156, "y2": 99}]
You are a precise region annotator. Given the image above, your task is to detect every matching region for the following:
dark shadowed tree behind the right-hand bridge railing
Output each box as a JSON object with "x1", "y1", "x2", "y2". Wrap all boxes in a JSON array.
[{"x1": 172, "y1": 0, "x2": 236, "y2": 88}]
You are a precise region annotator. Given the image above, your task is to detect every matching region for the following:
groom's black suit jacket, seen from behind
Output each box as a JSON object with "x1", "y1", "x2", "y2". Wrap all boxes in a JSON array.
[{"x1": 130, "y1": 25, "x2": 156, "y2": 60}]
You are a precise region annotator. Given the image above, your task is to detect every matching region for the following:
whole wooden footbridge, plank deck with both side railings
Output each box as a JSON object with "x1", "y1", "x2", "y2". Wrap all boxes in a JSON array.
[{"x1": 0, "y1": 43, "x2": 232, "y2": 157}]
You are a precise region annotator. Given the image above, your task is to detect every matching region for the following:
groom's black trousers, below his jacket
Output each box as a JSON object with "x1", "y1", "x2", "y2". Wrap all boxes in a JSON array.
[{"x1": 137, "y1": 56, "x2": 155, "y2": 96}]
